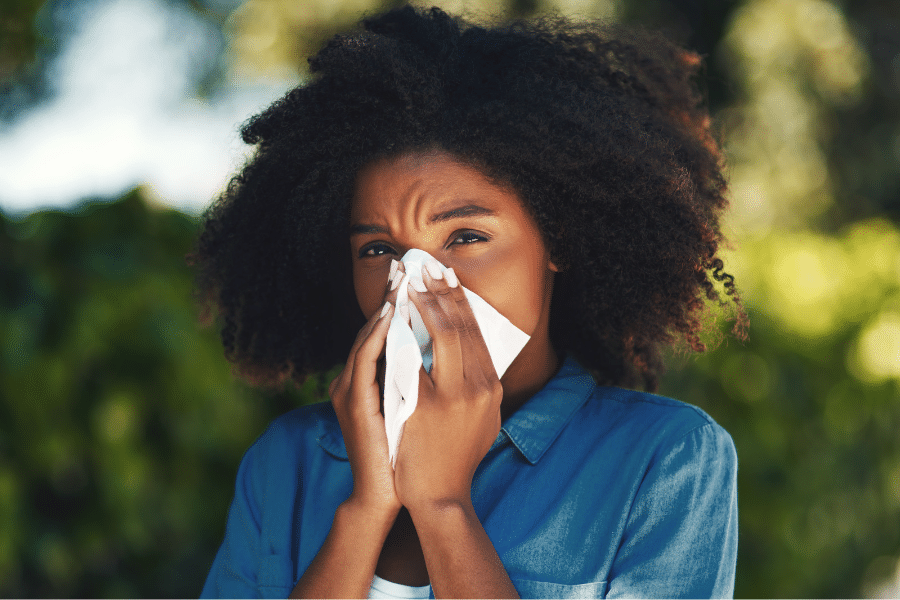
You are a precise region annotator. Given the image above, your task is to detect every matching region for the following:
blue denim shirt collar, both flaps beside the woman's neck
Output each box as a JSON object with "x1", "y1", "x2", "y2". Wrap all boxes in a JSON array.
[{"x1": 317, "y1": 355, "x2": 596, "y2": 465}]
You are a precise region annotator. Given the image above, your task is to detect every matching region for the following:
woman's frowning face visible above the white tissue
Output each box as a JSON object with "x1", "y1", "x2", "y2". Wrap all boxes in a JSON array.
[{"x1": 350, "y1": 152, "x2": 557, "y2": 346}]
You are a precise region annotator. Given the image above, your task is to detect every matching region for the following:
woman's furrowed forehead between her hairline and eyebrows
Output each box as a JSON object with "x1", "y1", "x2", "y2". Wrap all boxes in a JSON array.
[{"x1": 351, "y1": 151, "x2": 521, "y2": 218}]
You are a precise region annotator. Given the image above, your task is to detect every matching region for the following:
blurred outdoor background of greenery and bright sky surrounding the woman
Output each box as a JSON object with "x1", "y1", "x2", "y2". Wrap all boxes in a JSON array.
[{"x1": 0, "y1": 0, "x2": 900, "y2": 597}]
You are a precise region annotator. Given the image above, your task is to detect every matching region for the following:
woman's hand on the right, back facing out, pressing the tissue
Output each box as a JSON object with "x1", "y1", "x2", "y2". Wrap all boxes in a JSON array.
[{"x1": 394, "y1": 269, "x2": 503, "y2": 512}]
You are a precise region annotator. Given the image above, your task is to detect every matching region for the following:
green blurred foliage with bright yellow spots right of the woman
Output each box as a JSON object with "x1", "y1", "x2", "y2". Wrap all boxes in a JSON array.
[{"x1": 661, "y1": 220, "x2": 900, "y2": 598}]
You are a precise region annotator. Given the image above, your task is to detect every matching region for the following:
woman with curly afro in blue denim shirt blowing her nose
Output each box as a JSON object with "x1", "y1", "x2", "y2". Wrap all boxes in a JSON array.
[{"x1": 193, "y1": 7, "x2": 746, "y2": 598}]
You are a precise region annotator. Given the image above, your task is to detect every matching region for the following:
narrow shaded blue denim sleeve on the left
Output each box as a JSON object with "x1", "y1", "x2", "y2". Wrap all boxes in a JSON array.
[{"x1": 200, "y1": 424, "x2": 284, "y2": 598}]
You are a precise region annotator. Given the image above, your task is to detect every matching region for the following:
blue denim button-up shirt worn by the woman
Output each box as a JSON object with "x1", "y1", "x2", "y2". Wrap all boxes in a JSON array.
[{"x1": 202, "y1": 357, "x2": 738, "y2": 598}]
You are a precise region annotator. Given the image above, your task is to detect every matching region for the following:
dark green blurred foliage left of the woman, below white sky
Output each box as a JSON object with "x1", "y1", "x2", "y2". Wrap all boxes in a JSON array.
[{"x1": 0, "y1": 192, "x2": 338, "y2": 597}]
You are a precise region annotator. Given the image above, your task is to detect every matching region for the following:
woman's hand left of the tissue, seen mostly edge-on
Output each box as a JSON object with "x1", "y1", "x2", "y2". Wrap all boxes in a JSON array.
[{"x1": 328, "y1": 262, "x2": 403, "y2": 515}]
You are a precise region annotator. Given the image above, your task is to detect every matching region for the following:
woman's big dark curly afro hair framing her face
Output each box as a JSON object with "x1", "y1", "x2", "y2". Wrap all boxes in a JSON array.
[{"x1": 189, "y1": 6, "x2": 747, "y2": 391}]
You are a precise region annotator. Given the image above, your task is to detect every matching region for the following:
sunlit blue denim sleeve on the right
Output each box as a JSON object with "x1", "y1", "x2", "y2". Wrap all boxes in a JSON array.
[{"x1": 606, "y1": 423, "x2": 738, "y2": 598}]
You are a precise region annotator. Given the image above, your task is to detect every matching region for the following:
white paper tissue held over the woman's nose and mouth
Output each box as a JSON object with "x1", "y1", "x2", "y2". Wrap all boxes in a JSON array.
[{"x1": 384, "y1": 248, "x2": 531, "y2": 466}]
